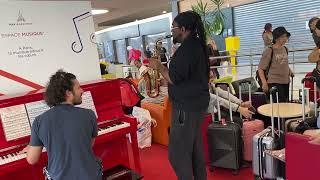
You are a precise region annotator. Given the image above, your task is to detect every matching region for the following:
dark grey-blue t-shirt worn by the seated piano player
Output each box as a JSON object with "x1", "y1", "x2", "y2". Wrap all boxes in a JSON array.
[{"x1": 30, "y1": 104, "x2": 101, "y2": 180}]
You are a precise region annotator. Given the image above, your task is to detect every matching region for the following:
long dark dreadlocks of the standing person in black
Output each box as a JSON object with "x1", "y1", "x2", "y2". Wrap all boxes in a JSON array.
[{"x1": 174, "y1": 11, "x2": 210, "y2": 75}]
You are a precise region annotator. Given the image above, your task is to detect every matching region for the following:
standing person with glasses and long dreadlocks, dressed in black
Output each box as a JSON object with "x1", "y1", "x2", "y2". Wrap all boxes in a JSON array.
[{"x1": 149, "y1": 11, "x2": 210, "y2": 180}]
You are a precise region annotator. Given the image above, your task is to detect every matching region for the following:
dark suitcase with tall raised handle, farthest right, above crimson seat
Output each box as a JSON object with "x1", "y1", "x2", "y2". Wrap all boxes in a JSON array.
[{"x1": 285, "y1": 76, "x2": 317, "y2": 134}]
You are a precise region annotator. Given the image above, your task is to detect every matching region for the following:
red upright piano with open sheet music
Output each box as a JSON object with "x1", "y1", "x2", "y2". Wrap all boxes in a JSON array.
[{"x1": 0, "y1": 80, "x2": 141, "y2": 180}]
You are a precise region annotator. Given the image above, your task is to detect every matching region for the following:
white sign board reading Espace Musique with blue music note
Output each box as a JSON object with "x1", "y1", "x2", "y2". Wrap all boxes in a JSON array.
[{"x1": 0, "y1": 1, "x2": 100, "y2": 95}]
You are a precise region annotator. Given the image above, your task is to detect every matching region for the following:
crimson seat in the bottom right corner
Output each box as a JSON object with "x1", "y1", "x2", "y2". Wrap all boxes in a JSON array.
[{"x1": 286, "y1": 132, "x2": 320, "y2": 180}]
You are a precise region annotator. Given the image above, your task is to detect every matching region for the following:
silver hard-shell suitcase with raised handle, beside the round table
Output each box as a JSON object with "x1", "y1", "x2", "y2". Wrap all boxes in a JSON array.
[{"x1": 252, "y1": 88, "x2": 281, "y2": 179}]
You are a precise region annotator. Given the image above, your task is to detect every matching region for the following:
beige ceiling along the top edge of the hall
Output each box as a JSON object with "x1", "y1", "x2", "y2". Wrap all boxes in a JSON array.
[{"x1": 29, "y1": 0, "x2": 259, "y2": 31}]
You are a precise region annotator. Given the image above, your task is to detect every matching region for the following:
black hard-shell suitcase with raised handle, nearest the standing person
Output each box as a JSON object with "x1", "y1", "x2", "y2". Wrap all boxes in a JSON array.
[{"x1": 207, "y1": 83, "x2": 242, "y2": 175}]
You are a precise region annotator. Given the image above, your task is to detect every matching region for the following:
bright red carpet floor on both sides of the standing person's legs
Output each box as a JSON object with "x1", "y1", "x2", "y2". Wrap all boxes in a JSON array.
[{"x1": 140, "y1": 144, "x2": 253, "y2": 180}]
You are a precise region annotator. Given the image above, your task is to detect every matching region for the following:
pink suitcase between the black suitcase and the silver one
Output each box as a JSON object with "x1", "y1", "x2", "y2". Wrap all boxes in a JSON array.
[{"x1": 239, "y1": 81, "x2": 264, "y2": 161}]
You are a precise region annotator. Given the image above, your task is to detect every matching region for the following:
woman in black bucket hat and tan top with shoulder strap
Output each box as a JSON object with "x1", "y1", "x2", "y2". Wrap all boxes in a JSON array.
[{"x1": 258, "y1": 26, "x2": 294, "y2": 102}]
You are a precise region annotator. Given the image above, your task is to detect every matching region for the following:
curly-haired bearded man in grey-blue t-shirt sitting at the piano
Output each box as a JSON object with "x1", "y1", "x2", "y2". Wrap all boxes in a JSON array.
[{"x1": 21, "y1": 70, "x2": 102, "y2": 180}]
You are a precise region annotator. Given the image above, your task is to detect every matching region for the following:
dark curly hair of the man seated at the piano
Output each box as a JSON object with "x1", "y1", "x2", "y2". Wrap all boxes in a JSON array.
[{"x1": 45, "y1": 69, "x2": 76, "y2": 107}]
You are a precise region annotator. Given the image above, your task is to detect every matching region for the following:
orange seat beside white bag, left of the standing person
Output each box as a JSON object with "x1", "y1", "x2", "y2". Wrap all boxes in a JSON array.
[{"x1": 141, "y1": 96, "x2": 172, "y2": 146}]
